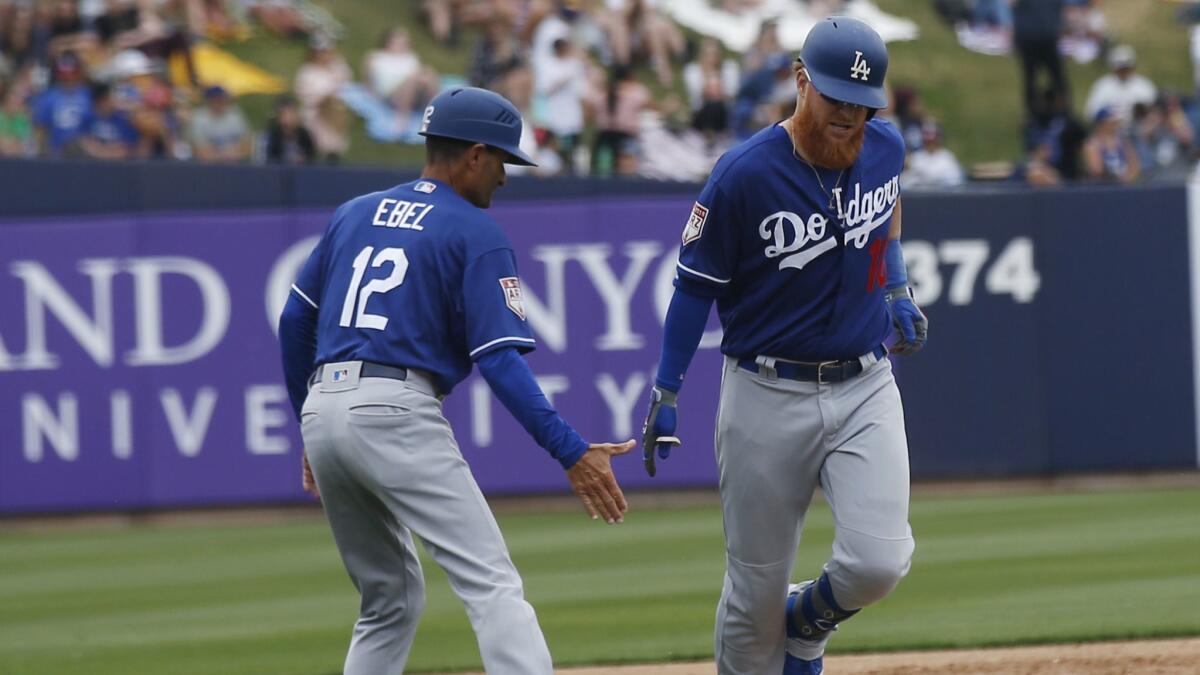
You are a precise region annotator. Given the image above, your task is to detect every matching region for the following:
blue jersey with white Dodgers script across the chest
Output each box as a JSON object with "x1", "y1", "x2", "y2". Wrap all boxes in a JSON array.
[{"x1": 676, "y1": 119, "x2": 904, "y2": 362}]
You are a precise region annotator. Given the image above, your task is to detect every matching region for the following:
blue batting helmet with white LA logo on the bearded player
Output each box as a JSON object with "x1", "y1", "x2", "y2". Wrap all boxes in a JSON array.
[{"x1": 799, "y1": 17, "x2": 888, "y2": 109}]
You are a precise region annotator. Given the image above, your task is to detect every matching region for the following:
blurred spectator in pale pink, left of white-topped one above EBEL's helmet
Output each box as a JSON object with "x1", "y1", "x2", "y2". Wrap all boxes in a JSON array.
[{"x1": 294, "y1": 34, "x2": 353, "y2": 161}]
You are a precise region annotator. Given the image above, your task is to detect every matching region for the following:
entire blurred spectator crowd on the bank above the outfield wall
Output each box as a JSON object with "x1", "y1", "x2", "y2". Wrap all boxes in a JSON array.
[{"x1": 0, "y1": 0, "x2": 1200, "y2": 183}]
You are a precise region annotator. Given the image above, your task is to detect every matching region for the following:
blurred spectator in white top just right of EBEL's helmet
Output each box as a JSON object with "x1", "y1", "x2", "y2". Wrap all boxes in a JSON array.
[{"x1": 534, "y1": 37, "x2": 587, "y2": 173}]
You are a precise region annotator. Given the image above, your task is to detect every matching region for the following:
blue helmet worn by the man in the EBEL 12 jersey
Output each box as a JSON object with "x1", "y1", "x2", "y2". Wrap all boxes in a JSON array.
[{"x1": 420, "y1": 86, "x2": 538, "y2": 167}]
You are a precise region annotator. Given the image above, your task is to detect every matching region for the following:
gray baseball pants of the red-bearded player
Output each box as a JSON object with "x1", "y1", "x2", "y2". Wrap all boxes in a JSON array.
[{"x1": 715, "y1": 358, "x2": 913, "y2": 675}]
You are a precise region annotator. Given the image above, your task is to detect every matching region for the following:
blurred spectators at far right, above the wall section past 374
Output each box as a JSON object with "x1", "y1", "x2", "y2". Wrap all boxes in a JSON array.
[{"x1": 935, "y1": 0, "x2": 1200, "y2": 186}]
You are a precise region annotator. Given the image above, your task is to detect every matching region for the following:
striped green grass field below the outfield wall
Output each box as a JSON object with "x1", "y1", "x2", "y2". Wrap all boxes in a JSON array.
[{"x1": 0, "y1": 489, "x2": 1200, "y2": 675}]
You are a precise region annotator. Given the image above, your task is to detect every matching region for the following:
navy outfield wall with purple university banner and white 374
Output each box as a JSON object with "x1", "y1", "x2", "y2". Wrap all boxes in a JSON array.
[{"x1": 0, "y1": 163, "x2": 1200, "y2": 513}]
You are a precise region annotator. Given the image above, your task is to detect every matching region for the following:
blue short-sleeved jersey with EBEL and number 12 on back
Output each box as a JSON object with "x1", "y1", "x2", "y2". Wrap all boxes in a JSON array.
[{"x1": 292, "y1": 179, "x2": 534, "y2": 394}]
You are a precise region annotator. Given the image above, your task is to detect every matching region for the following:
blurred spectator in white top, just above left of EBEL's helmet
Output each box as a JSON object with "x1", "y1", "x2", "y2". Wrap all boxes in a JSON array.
[{"x1": 362, "y1": 26, "x2": 439, "y2": 119}]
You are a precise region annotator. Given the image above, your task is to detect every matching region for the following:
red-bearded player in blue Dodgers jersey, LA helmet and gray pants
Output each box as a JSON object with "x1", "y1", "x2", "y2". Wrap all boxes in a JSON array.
[{"x1": 643, "y1": 17, "x2": 928, "y2": 675}]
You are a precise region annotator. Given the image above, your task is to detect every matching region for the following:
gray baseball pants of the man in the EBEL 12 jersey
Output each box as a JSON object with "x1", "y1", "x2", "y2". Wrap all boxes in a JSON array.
[{"x1": 301, "y1": 369, "x2": 553, "y2": 675}]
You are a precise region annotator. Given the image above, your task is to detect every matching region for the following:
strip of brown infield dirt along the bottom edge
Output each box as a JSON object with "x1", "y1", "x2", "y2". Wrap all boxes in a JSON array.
[{"x1": 484, "y1": 638, "x2": 1200, "y2": 675}]
